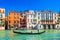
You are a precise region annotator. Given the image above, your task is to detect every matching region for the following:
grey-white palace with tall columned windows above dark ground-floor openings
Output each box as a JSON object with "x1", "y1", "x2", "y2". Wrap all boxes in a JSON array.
[{"x1": 38, "y1": 10, "x2": 56, "y2": 29}]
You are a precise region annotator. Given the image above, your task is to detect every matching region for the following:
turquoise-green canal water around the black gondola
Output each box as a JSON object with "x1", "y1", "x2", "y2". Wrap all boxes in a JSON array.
[{"x1": 0, "y1": 30, "x2": 60, "y2": 40}]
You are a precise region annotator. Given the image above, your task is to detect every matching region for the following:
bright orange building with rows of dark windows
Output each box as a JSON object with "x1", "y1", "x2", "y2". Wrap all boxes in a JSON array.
[{"x1": 8, "y1": 11, "x2": 20, "y2": 27}]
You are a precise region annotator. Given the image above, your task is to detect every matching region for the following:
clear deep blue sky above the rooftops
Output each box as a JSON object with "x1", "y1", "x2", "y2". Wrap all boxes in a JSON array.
[{"x1": 0, "y1": 0, "x2": 60, "y2": 15}]
